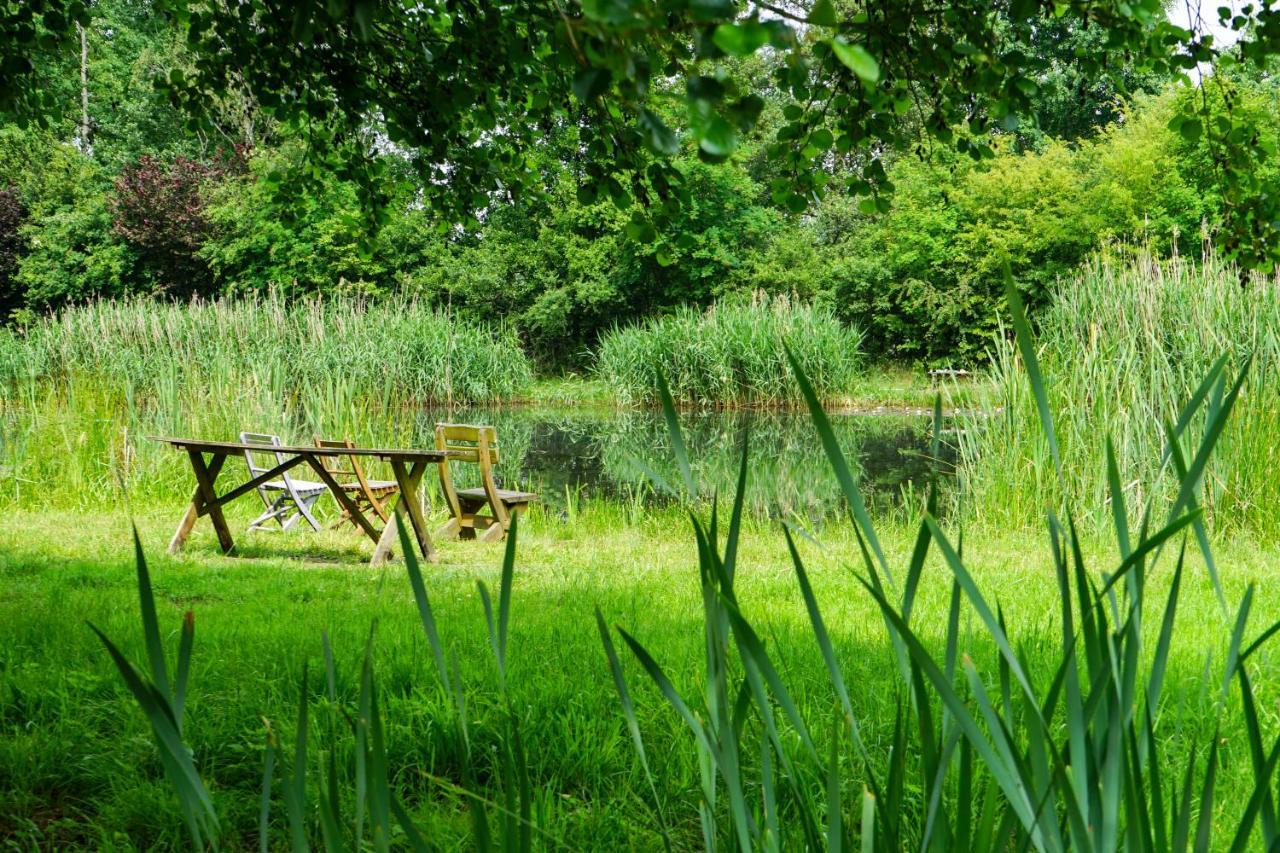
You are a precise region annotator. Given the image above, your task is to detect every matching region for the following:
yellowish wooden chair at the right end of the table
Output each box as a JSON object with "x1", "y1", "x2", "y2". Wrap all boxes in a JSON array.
[{"x1": 435, "y1": 424, "x2": 538, "y2": 542}]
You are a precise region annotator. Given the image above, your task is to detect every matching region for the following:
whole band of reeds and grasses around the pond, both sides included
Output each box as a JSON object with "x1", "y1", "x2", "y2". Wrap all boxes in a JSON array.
[{"x1": 0, "y1": 247, "x2": 1280, "y2": 538}]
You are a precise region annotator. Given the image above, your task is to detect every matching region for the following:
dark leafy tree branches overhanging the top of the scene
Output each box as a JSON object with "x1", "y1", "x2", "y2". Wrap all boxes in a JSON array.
[{"x1": 0, "y1": 0, "x2": 1280, "y2": 263}]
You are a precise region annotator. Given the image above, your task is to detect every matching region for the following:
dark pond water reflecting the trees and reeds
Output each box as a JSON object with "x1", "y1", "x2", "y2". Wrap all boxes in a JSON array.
[{"x1": 399, "y1": 407, "x2": 955, "y2": 520}]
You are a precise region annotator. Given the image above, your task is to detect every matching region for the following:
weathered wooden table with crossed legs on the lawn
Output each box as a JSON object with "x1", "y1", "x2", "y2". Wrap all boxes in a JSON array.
[{"x1": 150, "y1": 435, "x2": 452, "y2": 566}]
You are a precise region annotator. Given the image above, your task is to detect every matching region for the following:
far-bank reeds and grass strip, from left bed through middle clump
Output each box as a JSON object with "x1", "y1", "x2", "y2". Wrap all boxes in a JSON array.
[{"x1": 0, "y1": 295, "x2": 984, "y2": 414}]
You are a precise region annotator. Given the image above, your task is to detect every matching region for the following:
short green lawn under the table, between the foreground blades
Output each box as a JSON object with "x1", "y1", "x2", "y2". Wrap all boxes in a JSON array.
[{"x1": 0, "y1": 502, "x2": 1280, "y2": 849}]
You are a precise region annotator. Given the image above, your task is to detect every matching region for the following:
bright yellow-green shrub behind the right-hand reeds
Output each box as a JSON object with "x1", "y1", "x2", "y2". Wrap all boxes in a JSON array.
[{"x1": 815, "y1": 95, "x2": 1211, "y2": 365}]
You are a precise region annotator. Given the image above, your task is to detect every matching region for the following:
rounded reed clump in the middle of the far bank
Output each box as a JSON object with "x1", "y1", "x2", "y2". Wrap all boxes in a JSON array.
[{"x1": 595, "y1": 300, "x2": 863, "y2": 407}]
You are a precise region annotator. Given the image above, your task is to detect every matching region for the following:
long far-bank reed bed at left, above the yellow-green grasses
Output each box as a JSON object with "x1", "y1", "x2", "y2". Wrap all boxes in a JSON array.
[{"x1": 0, "y1": 295, "x2": 532, "y2": 402}]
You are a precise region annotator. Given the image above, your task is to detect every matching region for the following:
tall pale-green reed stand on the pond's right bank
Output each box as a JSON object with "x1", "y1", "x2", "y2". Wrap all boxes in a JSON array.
[{"x1": 960, "y1": 250, "x2": 1280, "y2": 539}]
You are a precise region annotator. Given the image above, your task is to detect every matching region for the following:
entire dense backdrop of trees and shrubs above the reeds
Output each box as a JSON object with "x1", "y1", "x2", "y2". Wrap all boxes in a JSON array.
[{"x1": 0, "y1": 0, "x2": 1280, "y2": 370}]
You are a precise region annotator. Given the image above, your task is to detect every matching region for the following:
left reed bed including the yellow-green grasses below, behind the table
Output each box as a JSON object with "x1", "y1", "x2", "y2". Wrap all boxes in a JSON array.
[{"x1": 0, "y1": 297, "x2": 532, "y2": 506}]
